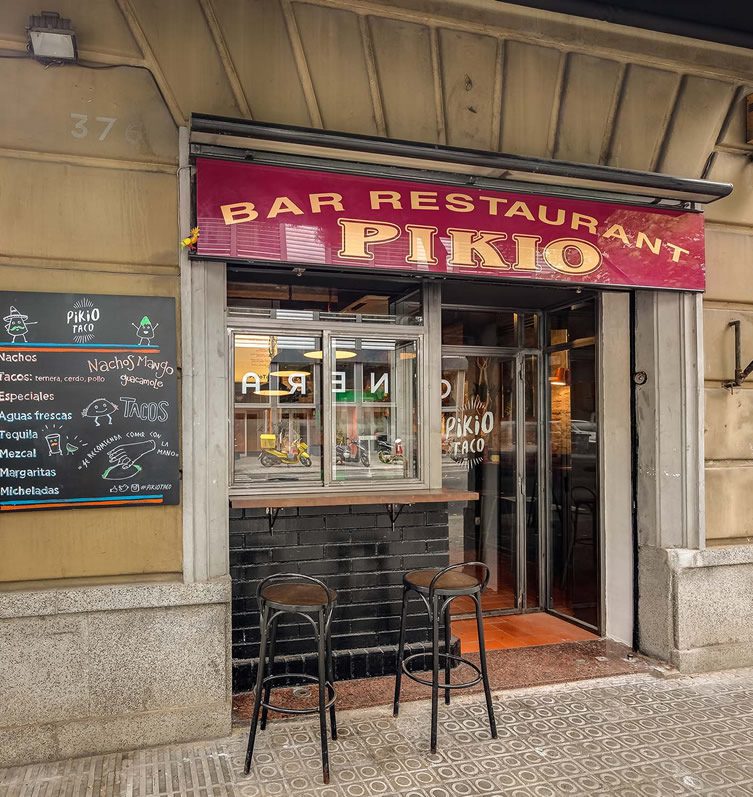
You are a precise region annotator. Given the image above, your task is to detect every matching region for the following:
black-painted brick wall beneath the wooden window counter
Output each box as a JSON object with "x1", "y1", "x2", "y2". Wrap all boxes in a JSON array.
[{"x1": 230, "y1": 504, "x2": 448, "y2": 691}]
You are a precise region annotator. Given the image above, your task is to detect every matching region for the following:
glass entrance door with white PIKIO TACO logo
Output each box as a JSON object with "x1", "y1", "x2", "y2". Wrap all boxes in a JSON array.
[{"x1": 442, "y1": 347, "x2": 539, "y2": 614}]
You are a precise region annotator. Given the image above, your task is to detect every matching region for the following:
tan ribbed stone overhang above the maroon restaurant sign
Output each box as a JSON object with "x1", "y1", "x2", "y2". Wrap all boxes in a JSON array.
[{"x1": 0, "y1": 0, "x2": 753, "y2": 225}]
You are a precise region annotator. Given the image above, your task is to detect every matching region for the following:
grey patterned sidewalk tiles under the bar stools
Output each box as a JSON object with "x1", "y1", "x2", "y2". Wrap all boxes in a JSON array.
[{"x1": 0, "y1": 669, "x2": 753, "y2": 797}]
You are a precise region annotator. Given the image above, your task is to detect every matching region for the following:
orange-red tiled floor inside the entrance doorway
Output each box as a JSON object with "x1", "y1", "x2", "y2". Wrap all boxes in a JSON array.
[{"x1": 452, "y1": 612, "x2": 598, "y2": 654}]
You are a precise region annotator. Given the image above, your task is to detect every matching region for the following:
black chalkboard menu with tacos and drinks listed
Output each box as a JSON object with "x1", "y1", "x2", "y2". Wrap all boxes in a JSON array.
[{"x1": 0, "y1": 291, "x2": 180, "y2": 513}]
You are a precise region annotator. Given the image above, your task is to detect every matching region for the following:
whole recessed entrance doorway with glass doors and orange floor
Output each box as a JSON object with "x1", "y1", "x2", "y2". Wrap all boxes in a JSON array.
[{"x1": 441, "y1": 286, "x2": 601, "y2": 652}]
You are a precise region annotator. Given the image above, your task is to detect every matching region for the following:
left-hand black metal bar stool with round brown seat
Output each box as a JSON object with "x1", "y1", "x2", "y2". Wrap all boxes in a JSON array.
[{"x1": 244, "y1": 573, "x2": 337, "y2": 783}]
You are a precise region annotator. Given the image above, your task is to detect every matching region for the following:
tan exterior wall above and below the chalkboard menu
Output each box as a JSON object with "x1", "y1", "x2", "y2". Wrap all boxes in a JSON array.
[{"x1": 0, "y1": 59, "x2": 182, "y2": 585}]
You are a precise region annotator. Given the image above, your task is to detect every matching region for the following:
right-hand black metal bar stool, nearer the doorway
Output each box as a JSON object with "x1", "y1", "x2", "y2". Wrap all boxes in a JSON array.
[{"x1": 392, "y1": 562, "x2": 497, "y2": 753}]
